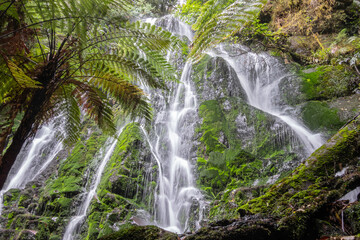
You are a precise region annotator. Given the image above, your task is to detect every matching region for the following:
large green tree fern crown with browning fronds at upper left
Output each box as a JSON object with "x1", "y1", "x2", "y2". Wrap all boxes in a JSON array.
[{"x1": 0, "y1": 0, "x2": 183, "y2": 165}]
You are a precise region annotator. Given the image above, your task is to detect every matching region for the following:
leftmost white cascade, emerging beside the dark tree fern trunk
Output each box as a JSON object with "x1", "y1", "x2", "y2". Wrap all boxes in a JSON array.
[{"x1": 0, "y1": 116, "x2": 63, "y2": 213}]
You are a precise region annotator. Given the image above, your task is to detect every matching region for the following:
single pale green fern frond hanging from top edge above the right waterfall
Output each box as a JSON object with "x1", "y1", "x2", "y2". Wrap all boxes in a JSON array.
[{"x1": 189, "y1": 0, "x2": 267, "y2": 60}]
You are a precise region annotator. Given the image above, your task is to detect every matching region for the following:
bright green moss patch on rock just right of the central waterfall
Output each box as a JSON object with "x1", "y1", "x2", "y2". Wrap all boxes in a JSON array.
[{"x1": 197, "y1": 100, "x2": 262, "y2": 197}]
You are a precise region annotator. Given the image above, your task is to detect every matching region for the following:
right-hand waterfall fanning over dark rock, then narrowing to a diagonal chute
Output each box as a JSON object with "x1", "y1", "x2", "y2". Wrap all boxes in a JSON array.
[{"x1": 208, "y1": 45, "x2": 323, "y2": 155}]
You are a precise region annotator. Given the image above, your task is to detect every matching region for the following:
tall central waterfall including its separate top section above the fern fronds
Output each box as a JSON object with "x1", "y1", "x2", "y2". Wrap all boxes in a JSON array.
[{"x1": 144, "y1": 16, "x2": 205, "y2": 233}]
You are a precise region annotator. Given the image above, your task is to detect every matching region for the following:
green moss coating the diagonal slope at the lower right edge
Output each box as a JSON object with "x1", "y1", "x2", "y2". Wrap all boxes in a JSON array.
[{"x1": 241, "y1": 118, "x2": 360, "y2": 217}]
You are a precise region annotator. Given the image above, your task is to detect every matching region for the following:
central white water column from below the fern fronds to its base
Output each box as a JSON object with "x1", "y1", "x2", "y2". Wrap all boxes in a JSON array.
[{"x1": 152, "y1": 62, "x2": 203, "y2": 233}]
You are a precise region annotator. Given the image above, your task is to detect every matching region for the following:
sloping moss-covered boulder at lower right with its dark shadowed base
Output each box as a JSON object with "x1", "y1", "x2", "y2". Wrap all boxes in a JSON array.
[{"x1": 186, "y1": 117, "x2": 360, "y2": 240}]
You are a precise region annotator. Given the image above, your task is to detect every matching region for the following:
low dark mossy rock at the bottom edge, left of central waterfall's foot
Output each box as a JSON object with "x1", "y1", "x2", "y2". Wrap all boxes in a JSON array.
[{"x1": 99, "y1": 224, "x2": 178, "y2": 240}]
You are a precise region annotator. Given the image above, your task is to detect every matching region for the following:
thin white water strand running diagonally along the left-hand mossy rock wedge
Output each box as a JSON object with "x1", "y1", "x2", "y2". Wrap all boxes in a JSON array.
[{"x1": 63, "y1": 127, "x2": 124, "y2": 240}]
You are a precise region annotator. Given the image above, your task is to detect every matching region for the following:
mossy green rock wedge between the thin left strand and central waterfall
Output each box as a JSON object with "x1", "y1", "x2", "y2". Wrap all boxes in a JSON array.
[{"x1": 77, "y1": 123, "x2": 152, "y2": 240}]
